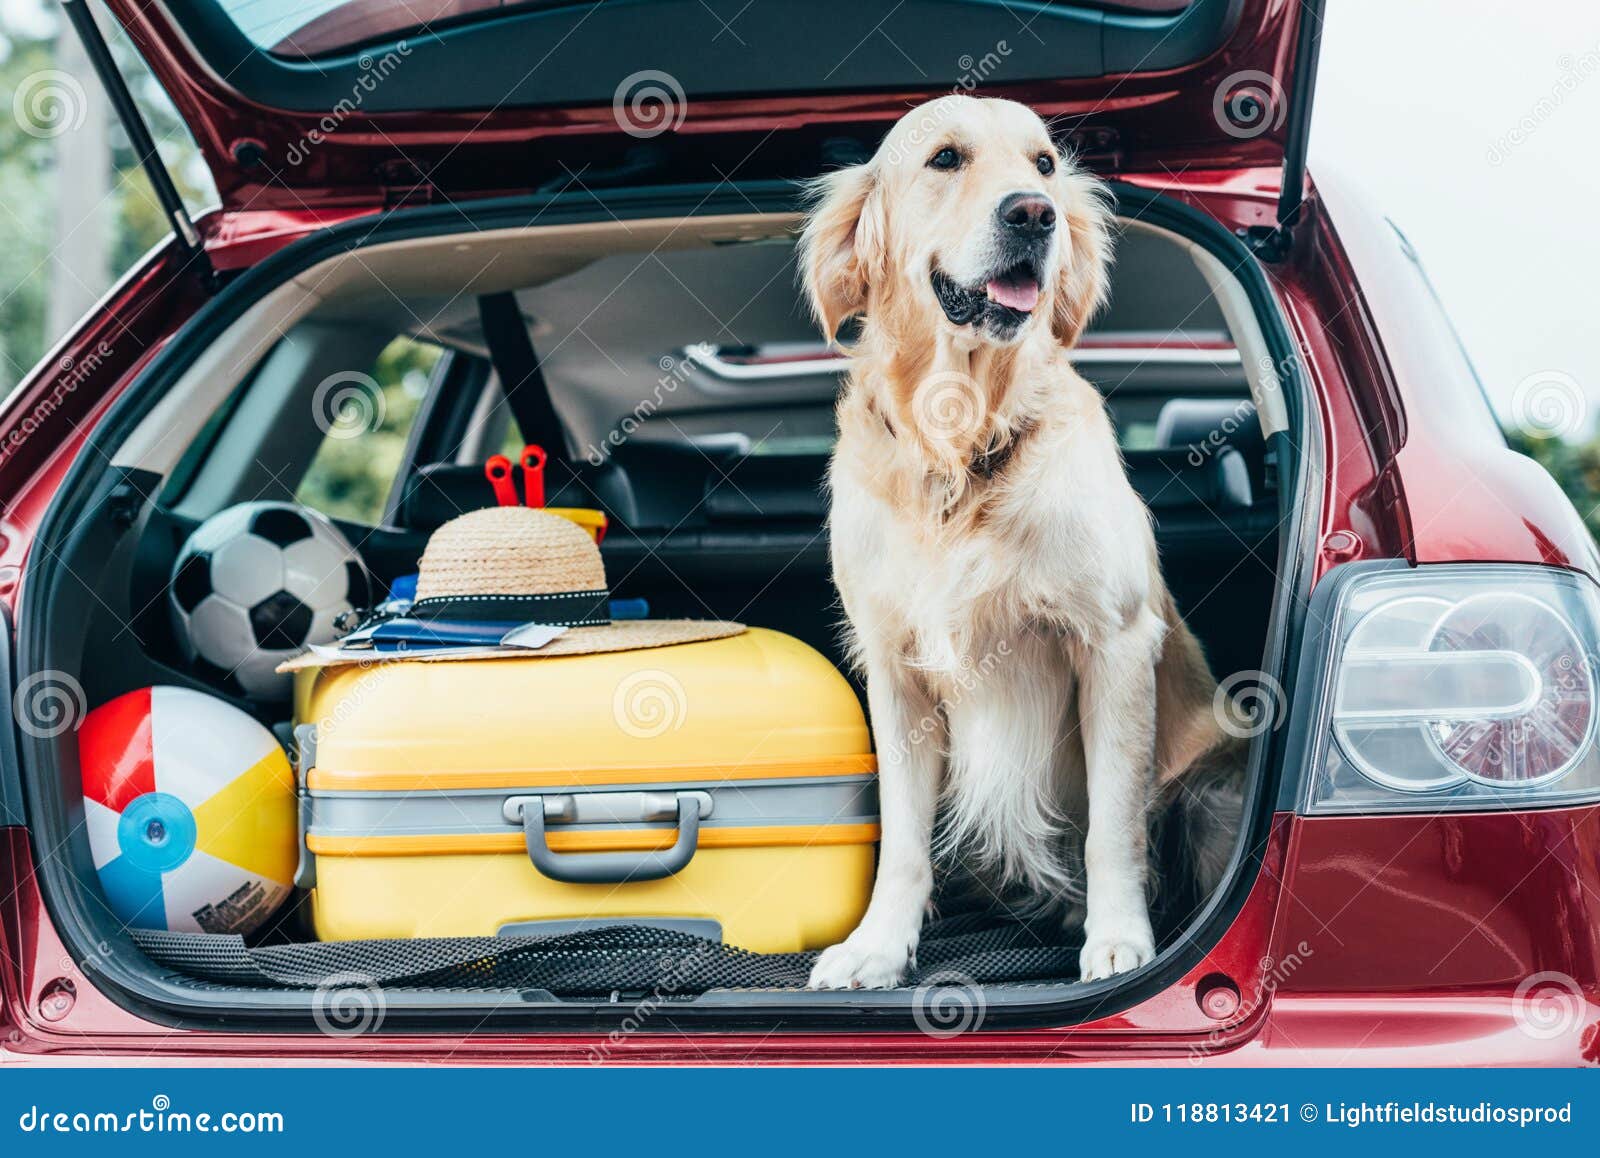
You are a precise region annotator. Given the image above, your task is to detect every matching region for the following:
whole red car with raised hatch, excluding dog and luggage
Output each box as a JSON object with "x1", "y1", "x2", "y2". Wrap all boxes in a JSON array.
[{"x1": 0, "y1": 0, "x2": 1600, "y2": 1065}]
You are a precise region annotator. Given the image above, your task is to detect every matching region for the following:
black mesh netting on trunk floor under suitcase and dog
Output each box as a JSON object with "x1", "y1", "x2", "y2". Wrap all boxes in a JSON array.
[{"x1": 131, "y1": 913, "x2": 1082, "y2": 996}]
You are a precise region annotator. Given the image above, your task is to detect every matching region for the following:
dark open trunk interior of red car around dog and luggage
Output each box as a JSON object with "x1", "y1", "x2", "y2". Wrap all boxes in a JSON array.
[{"x1": 19, "y1": 184, "x2": 1315, "y2": 1028}]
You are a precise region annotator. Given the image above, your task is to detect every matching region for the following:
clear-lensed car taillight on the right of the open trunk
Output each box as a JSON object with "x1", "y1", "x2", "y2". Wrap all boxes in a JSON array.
[{"x1": 1302, "y1": 565, "x2": 1600, "y2": 813}]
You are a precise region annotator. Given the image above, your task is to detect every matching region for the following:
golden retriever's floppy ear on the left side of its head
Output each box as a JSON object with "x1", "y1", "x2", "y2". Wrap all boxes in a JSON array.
[{"x1": 798, "y1": 162, "x2": 885, "y2": 341}]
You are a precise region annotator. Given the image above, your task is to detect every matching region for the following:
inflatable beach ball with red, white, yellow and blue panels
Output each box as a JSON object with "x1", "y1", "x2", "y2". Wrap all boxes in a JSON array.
[{"x1": 78, "y1": 688, "x2": 298, "y2": 932}]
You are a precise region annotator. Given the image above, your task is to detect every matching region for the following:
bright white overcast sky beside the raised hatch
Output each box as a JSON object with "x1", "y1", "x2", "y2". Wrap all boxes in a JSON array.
[{"x1": 9, "y1": 0, "x2": 1600, "y2": 416}]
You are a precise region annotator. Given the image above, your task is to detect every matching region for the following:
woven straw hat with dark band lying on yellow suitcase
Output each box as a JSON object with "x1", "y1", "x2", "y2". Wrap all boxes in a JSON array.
[{"x1": 278, "y1": 507, "x2": 744, "y2": 672}]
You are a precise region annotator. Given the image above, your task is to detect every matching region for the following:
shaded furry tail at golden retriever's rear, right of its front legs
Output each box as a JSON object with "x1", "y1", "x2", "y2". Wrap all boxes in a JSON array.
[{"x1": 1152, "y1": 737, "x2": 1250, "y2": 913}]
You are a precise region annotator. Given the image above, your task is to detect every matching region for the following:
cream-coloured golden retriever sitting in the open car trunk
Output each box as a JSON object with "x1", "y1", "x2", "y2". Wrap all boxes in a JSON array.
[{"x1": 800, "y1": 96, "x2": 1232, "y2": 988}]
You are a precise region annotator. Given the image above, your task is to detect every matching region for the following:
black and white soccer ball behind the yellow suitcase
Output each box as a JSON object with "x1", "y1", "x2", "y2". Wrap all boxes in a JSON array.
[{"x1": 170, "y1": 502, "x2": 371, "y2": 701}]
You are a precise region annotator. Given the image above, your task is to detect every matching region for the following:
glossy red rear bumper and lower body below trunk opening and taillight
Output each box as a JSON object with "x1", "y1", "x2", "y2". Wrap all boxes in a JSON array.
[{"x1": 0, "y1": 808, "x2": 1600, "y2": 1065}]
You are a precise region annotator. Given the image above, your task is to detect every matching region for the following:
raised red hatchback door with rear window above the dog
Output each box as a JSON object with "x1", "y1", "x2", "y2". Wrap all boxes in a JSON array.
[{"x1": 96, "y1": 0, "x2": 1320, "y2": 210}]
